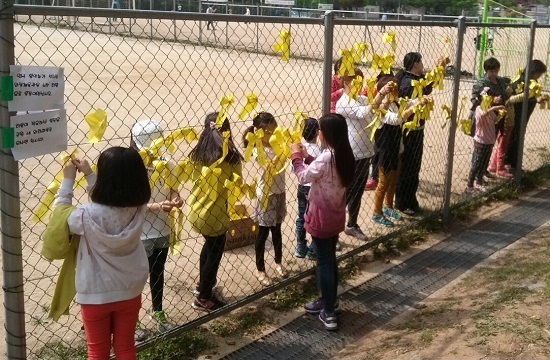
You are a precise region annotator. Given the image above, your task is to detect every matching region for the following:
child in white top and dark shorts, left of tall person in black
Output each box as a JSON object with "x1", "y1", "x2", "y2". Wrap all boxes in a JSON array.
[{"x1": 372, "y1": 75, "x2": 414, "y2": 226}]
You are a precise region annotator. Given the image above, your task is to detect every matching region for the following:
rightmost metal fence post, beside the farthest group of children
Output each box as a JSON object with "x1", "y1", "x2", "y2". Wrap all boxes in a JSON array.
[{"x1": 514, "y1": 20, "x2": 537, "y2": 183}]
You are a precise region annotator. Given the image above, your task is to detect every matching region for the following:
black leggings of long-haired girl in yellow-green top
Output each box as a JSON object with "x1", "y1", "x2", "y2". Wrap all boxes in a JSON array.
[{"x1": 199, "y1": 234, "x2": 225, "y2": 299}]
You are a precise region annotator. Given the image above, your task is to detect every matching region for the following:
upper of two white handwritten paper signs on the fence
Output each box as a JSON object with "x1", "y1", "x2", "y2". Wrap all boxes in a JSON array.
[{"x1": 8, "y1": 65, "x2": 65, "y2": 111}]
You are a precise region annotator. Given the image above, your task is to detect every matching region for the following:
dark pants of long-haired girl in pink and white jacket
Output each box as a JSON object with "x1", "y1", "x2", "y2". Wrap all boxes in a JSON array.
[{"x1": 312, "y1": 235, "x2": 338, "y2": 314}]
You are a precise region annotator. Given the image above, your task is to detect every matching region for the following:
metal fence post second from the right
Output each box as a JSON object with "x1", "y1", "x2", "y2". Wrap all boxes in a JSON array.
[{"x1": 443, "y1": 16, "x2": 466, "y2": 223}]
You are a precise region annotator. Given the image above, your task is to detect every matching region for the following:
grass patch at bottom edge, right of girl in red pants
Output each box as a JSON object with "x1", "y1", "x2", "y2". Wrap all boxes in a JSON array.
[{"x1": 138, "y1": 328, "x2": 215, "y2": 360}]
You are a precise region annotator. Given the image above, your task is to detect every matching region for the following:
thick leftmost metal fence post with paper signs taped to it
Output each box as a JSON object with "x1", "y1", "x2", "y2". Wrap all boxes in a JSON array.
[{"x1": 0, "y1": 0, "x2": 27, "y2": 359}]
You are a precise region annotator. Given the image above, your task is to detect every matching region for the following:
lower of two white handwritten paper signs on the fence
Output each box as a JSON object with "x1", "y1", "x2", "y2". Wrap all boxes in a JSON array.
[{"x1": 10, "y1": 109, "x2": 67, "y2": 160}]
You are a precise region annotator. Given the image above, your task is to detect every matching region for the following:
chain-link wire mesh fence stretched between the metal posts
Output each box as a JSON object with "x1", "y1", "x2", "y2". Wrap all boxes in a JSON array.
[{"x1": 2, "y1": 6, "x2": 550, "y2": 359}]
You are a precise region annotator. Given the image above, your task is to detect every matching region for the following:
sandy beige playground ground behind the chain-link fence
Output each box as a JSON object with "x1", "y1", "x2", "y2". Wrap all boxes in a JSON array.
[{"x1": 6, "y1": 14, "x2": 548, "y2": 358}]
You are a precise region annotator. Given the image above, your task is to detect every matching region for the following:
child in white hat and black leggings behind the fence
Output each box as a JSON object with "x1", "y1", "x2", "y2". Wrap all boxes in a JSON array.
[{"x1": 131, "y1": 120, "x2": 183, "y2": 341}]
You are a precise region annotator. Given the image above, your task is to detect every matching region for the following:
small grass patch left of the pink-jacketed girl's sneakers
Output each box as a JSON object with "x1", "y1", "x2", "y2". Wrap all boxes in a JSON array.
[{"x1": 208, "y1": 311, "x2": 266, "y2": 337}]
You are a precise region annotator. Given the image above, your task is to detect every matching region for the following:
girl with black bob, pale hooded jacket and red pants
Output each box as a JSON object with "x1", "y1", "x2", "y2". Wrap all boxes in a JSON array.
[{"x1": 54, "y1": 147, "x2": 151, "y2": 359}]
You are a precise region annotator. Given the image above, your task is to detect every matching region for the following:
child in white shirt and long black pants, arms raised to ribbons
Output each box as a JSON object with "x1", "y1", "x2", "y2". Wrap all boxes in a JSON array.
[{"x1": 336, "y1": 68, "x2": 392, "y2": 241}]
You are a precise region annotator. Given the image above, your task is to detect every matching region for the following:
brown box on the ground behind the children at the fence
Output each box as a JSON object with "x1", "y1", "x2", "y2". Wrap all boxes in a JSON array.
[{"x1": 224, "y1": 205, "x2": 258, "y2": 251}]
